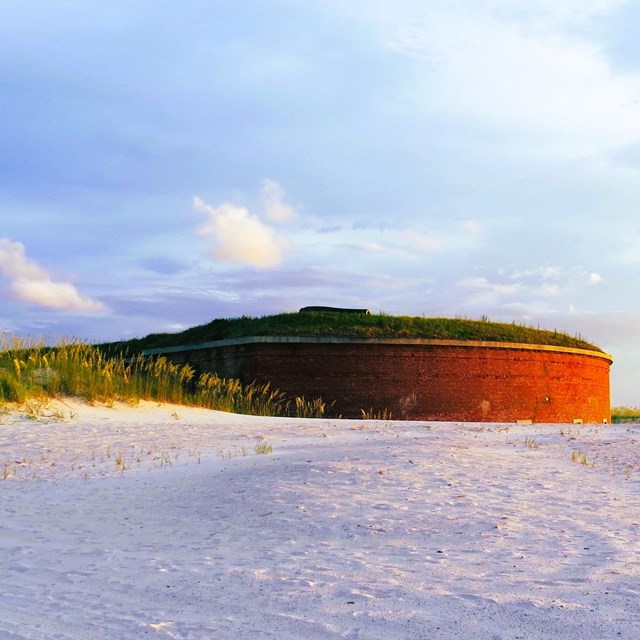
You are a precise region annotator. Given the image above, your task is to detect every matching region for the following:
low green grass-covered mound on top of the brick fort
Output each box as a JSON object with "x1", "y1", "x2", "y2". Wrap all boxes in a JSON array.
[{"x1": 109, "y1": 311, "x2": 601, "y2": 353}]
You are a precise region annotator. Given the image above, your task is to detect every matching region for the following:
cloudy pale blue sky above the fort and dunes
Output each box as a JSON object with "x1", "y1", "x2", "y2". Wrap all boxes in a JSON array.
[{"x1": 0, "y1": 0, "x2": 640, "y2": 405}]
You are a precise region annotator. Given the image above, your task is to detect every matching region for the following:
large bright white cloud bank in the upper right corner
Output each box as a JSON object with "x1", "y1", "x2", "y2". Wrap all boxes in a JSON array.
[{"x1": 340, "y1": 0, "x2": 640, "y2": 151}]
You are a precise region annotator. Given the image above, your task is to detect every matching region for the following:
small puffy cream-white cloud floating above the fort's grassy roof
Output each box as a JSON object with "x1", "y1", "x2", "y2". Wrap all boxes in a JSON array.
[{"x1": 193, "y1": 197, "x2": 288, "y2": 269}]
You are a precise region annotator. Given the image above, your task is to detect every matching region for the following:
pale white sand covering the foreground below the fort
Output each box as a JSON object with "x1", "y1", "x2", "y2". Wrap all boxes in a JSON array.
[{"x1": 0, "y1": 403, "x2": 640, "y2": 640}]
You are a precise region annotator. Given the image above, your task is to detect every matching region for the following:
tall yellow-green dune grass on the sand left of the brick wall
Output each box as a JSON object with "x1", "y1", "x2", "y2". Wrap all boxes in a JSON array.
[{"x1": 0, "y1": 337, "x2": 327, "y2": 417}]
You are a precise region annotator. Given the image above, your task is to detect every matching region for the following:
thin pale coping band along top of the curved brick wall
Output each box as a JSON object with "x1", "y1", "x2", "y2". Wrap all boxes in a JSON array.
[{"x1": 142, "y1": 336, "x2": 613, "y2": 364}]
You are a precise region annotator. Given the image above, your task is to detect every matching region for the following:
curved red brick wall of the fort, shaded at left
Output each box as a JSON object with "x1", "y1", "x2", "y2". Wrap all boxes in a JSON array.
[{"x1": 145, "y1": 337, "x2": 612, "y2": 422}]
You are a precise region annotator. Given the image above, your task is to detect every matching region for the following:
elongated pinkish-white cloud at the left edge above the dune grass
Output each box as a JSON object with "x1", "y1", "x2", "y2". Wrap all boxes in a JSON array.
[{"x1": 0, "y1": 238, "x2": 106, "y2": 313}]
